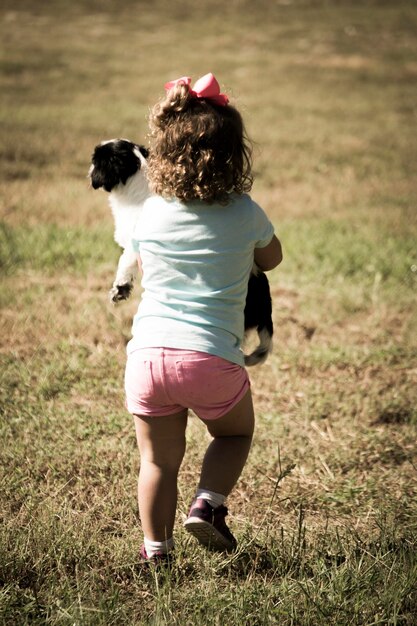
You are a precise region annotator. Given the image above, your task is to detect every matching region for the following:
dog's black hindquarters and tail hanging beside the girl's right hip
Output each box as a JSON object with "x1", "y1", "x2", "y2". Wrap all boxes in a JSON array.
[{"x1": 245, "y1": 268, "x2": 274, "y2": 367}]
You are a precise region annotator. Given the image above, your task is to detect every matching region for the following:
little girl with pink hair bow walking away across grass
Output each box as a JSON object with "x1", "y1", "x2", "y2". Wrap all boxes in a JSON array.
[{"x1": 125, "y1": 74, "x2": 282, "y2": 560}]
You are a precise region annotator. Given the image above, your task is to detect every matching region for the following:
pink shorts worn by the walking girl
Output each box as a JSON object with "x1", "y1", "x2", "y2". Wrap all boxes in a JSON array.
[{"x1": 125, "y1": 348, "x2": 250, "y2": 420}]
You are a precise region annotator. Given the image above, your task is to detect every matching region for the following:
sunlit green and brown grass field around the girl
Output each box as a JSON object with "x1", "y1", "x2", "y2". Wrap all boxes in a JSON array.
[{"x1": 0, "y1": 0, "x2": 417, "y2": 626}]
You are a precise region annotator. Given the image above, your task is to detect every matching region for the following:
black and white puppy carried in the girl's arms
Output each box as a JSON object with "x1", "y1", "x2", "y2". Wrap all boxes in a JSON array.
[{"x1": 89, "y1": 139, "x2": 273, "y2": 366}]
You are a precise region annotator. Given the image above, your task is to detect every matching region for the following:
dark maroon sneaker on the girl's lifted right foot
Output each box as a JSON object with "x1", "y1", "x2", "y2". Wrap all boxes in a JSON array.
[{"x1": 184, "y1": 498, "x2": 237, "y2": 551}]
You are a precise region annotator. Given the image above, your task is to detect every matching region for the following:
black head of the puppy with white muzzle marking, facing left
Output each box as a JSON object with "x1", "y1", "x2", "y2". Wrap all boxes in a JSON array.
[{"x1": 89, "y1": 139, "x2": 148, "y2": 192}]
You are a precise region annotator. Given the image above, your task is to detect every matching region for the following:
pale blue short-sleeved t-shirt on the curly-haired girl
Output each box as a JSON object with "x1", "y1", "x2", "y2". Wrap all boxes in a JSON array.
[{"x1": 128, "y1": 194, "x2": 274, "y2": 365}]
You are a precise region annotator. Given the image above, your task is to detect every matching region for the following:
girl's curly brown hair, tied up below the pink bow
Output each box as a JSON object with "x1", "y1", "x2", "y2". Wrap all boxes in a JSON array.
[{"x1": 148, "y1": 84, "x2": 253, "y2": 204}]
